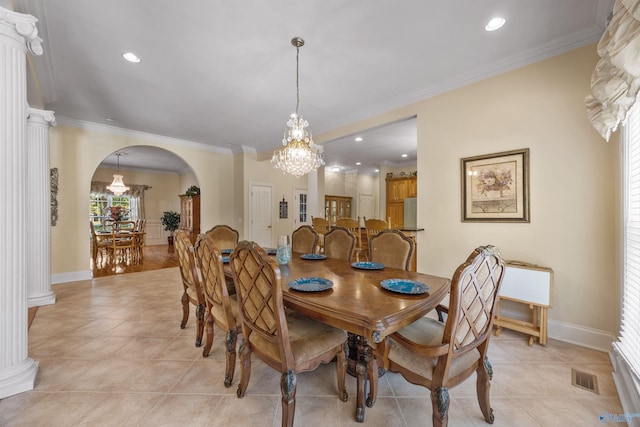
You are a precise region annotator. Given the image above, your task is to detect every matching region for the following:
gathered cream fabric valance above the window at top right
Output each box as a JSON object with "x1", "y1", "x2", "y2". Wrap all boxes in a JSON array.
[{"x1": 585, "y1": 0, "x2": 640, "y2": 141}]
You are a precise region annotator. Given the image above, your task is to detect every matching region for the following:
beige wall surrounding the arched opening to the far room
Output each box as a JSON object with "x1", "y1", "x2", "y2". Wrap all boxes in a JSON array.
[{"x1": 49, "y1": 125, "x2": 234, "y2": 277}]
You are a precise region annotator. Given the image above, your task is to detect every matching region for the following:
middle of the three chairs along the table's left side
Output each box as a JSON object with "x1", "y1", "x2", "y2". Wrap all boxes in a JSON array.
[{"x1": 194, "y1": 233, "x2": 241, "y2": 387}]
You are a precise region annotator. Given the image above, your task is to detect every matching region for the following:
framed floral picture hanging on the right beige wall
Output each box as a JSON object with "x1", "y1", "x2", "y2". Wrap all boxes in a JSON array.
[{"x1": 461, "y1": 148, "x2": 530, "y2": 222}]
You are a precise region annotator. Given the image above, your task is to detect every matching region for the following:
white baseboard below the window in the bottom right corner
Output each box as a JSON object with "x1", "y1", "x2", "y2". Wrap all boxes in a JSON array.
[{"x1": 609, "y1": 346, "x2": 640, "y2": 427}]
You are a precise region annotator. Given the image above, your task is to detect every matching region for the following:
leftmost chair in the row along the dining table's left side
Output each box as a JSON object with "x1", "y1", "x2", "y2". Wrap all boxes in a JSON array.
[{"x1": 173, "y1": 230, "x2": 206, "y2": 347}]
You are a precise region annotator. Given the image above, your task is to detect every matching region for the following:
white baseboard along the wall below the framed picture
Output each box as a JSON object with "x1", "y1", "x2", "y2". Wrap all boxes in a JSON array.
[{"x1": 502, "y1": 310, "x2": 616, "y2": 352}]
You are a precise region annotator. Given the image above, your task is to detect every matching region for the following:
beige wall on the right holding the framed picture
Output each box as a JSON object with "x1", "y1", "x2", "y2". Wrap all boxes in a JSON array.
[{"x1": 316, "y1": 45, "x2": 621, "y2": 347}]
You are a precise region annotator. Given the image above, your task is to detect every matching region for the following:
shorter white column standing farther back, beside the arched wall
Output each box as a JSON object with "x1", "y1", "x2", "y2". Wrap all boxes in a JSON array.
[{"x1": 25, "y1": 108, "x2": 56, "y2": 307}]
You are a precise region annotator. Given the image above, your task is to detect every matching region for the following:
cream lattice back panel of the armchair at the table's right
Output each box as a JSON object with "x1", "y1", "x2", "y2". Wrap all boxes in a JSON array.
[{"x1": 444, "y1": 246, "x2": 505, "y2": 353}]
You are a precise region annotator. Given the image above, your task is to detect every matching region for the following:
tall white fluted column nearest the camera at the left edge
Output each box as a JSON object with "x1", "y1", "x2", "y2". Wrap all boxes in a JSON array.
[{"x1": 0, "y1": 8, "x2": 42, "y2": 399}]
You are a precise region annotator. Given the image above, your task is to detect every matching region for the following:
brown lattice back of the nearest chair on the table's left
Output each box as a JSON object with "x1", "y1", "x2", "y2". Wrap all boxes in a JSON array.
[{"x1": 230, "y1": 241, "x2": 282, "y2": 342}]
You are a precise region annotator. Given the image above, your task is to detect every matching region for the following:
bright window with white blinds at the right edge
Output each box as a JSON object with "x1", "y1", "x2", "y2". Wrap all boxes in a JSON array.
[{"x1": 614, "y1": 103, "x2": 640, "y2": 377}]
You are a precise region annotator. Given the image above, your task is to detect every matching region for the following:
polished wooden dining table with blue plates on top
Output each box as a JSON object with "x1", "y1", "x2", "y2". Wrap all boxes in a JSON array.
[{"x1": 280, "y1": 253, "x2": 451, "y2": 422}]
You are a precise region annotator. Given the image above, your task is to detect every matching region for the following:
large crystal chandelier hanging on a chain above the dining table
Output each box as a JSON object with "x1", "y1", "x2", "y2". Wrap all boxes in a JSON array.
[{"x1": 271, "y1": 37, "x2": 324, "y2": 178}]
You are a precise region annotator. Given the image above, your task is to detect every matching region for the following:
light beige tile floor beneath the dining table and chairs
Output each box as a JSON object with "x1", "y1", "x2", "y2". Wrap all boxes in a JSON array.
[{"x1": 0, "y1": 268, "x2": 623, "y2": 427}]
